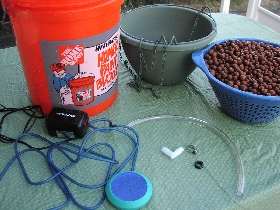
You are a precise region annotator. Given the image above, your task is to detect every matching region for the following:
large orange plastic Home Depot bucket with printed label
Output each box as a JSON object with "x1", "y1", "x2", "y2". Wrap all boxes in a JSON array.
[{"x1": 4, "y1": 0, "x2": 123, "y2": 115}]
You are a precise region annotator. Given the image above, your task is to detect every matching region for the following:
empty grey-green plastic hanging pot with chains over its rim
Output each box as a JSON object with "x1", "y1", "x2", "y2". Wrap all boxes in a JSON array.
[{"x1": 121, "y1": 4, "x2": 217, "y2": 85}]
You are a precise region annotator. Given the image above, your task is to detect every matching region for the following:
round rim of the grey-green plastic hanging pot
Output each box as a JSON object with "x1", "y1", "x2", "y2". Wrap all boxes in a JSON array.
[{"x1": 120, "y1": 4, "x2": 217, "y2": 51}]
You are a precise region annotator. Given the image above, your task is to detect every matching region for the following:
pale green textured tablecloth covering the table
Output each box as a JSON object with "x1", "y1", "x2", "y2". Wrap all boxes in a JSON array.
[{"x1": 0, "y1": 14, "x2": 280, "y2": 210}]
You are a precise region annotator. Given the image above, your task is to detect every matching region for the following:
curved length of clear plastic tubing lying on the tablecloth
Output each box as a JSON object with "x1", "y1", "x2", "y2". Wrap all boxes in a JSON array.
[{"x1": 128, "y1": 115, "x2": 245, "y2": 196}]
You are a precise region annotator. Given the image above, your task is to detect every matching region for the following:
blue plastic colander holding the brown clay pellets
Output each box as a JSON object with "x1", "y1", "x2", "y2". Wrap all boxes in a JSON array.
[{"x1": 192, "y1": 39, "x2": 280, "y2": 123}]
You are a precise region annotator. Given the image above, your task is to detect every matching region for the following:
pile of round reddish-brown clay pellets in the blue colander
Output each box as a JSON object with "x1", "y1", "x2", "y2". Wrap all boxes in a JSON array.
[{"x1": 204, "y1": 41, "x2": 280, "y2": 96}]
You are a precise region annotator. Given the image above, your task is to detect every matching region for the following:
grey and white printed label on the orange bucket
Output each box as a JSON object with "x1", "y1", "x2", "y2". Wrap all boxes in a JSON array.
[{"x1": 41, "y1": 27, "x2": 120, "y2": 109}]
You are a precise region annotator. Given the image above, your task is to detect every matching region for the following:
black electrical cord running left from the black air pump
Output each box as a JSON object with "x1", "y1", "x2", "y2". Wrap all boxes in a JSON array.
[{"x1": 0, "y1": 104, "x2": 75, "y2": 150}]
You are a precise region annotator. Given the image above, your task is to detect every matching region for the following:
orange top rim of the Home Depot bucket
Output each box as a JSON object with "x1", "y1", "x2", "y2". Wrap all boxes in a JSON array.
[{"x1": 3, "y1": 0, "x2": 118, "y2": 9}]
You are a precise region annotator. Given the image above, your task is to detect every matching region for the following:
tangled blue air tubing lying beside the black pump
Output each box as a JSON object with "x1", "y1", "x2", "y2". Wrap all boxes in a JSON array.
[{"x1": 0, "y1": 119, "x2": 139, "y2": 210}]
